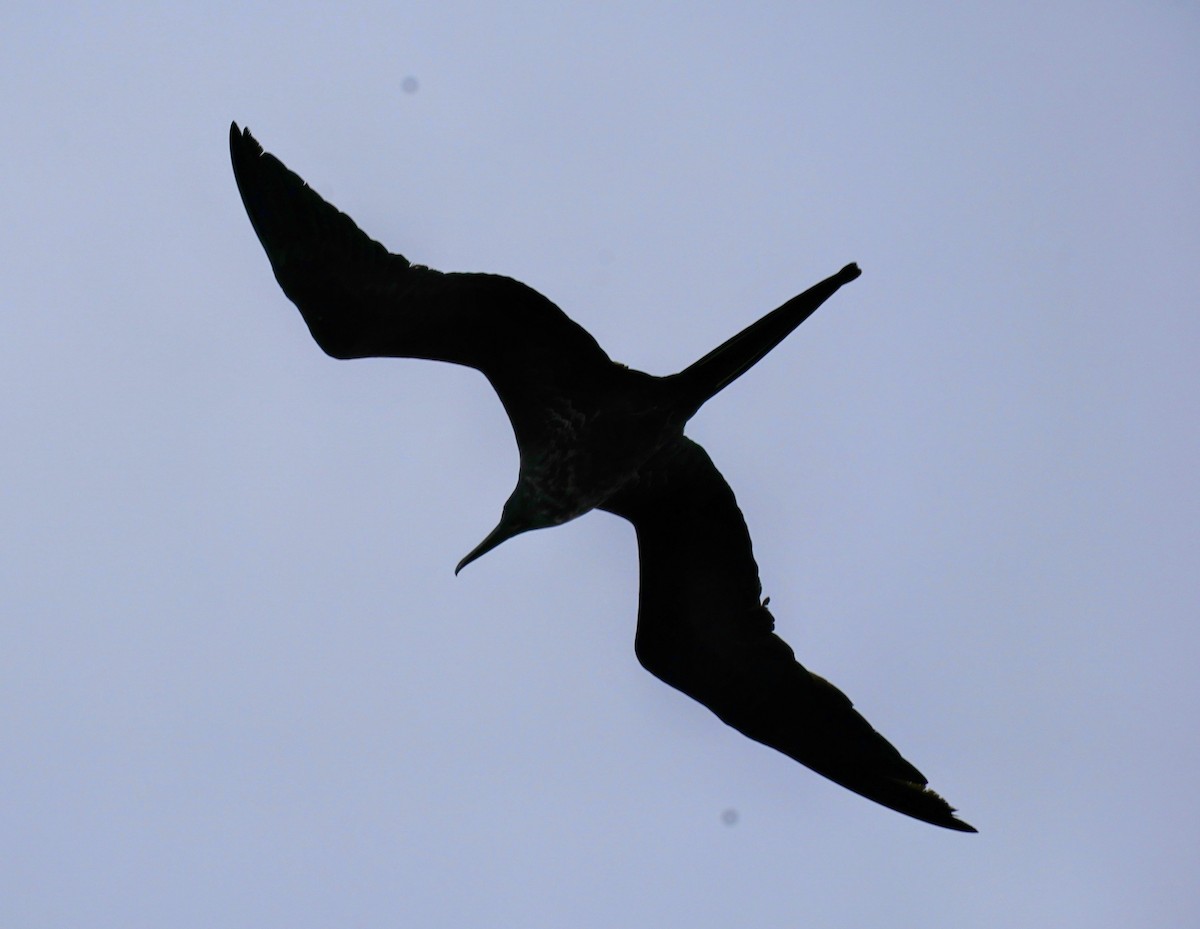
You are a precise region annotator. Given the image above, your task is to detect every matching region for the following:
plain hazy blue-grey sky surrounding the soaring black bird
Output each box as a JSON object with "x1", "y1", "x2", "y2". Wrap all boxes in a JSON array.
[{"x1": 0, "y1": 0, "x2": 1200, "y2": 929}]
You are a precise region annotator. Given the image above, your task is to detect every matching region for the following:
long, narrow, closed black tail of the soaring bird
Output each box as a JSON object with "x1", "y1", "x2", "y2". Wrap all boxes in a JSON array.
[{"x1": 672, "y1": 264, "x2": 862, "y2": 416}]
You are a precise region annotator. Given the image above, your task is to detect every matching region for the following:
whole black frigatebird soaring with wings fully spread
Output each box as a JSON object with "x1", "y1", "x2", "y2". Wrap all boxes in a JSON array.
[{"x1": 229, "y1": 122, "x2": 976, "y2": 832}]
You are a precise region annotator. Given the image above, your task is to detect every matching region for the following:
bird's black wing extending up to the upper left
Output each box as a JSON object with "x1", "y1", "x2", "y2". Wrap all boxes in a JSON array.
[{"x1": 229, "y1": 124, "x2": 612, "y2": 438}]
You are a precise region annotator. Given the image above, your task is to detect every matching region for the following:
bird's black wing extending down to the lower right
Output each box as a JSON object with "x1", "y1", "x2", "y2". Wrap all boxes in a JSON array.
[{"x1": 604, "y1": 438, "x2": 974, "y2": 832}]
